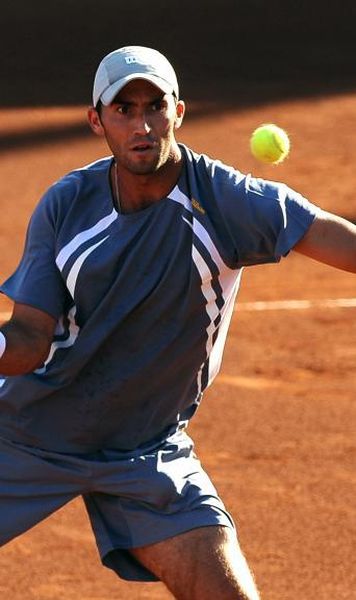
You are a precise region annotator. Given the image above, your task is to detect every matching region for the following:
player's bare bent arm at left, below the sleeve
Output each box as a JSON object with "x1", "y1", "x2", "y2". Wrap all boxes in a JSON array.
[{"x1": 0, "y1": 303, "x2": 56, "y2": 375}]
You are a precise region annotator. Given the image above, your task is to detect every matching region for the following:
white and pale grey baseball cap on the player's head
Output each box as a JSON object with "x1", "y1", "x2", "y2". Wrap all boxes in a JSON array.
[{"x1": 93, "y1": 46, "x2": 179, "y2": 106}]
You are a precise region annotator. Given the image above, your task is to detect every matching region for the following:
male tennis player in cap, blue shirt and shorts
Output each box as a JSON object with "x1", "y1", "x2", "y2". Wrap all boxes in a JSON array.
[{"x1": 0, "y1": 46, "x2": 356, "y2": 600}]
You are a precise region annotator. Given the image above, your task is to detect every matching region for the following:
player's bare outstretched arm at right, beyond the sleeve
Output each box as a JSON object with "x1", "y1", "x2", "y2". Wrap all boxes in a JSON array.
[{"x1": 293, "y1": 211, "x2": 356, "y2": 273}]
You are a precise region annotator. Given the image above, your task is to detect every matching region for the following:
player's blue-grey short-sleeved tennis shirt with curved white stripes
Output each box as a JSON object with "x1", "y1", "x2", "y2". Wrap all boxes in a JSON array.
[{"x1": 0, "y1": 145, "x2": 318, "y2": 452}]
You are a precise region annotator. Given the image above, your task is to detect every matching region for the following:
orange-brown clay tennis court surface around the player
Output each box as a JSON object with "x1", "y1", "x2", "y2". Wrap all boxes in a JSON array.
[{"x1": 0, "y1": 1, "x2": 356, "y2": 600}]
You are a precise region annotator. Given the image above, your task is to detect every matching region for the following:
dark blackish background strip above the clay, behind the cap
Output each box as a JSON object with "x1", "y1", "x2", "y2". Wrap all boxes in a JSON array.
[{"x1": 0, "y1": 0, "x2": 356, "y2": 106}]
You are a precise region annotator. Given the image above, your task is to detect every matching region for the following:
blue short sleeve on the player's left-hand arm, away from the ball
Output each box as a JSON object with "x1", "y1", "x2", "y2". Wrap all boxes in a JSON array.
[{"x1": 0, "y1": 190, "x2": 68, "y2": 318}]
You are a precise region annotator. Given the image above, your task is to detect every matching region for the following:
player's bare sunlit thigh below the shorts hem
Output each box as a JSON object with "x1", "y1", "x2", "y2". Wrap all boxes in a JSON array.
[{"x1": 131, "y1": 526, "x2": 259, "y2": 600}]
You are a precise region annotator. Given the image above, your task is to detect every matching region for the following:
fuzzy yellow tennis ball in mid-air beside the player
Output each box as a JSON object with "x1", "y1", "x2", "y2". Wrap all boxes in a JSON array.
[{"x1": 250, "y1": 123, "x2": 290, "y2": 164}]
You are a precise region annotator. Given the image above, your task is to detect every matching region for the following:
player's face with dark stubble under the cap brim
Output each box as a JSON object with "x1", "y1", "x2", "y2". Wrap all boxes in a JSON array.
[{"x1": 89, "y1": 79, "x2": 184, "y2": 175}]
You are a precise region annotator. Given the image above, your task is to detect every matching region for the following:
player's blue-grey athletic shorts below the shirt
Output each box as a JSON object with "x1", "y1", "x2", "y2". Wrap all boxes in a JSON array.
[{"x1": 0, "y1": 432, "x2": 234, "y2": 581}]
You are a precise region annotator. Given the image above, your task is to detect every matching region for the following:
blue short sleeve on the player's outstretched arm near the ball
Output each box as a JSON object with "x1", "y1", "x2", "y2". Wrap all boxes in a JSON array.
[{"x1": 211, "y1": 172, "x2": 320, "y2": 266}]
